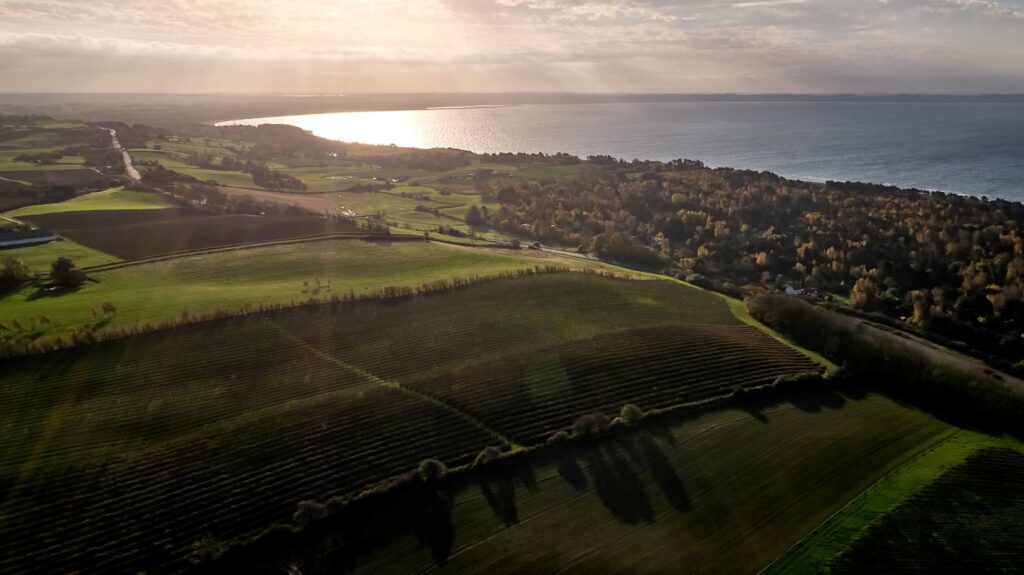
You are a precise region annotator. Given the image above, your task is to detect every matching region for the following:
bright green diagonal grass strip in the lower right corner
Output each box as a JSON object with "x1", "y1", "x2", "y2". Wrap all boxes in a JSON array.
[{"x1": 767, "y1": 431, "x2": 1024, "y2": 574}]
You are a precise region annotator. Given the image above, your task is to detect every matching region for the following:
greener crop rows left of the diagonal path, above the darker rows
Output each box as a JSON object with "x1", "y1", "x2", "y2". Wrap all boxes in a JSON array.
[{"x1": 0, "y1": 317, "x2": 376, "y2": 476}]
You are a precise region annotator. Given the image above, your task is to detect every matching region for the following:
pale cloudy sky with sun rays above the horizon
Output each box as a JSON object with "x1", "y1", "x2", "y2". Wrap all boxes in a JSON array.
[{"x1": 0, "y1": 0, "x2": 1024, "y2": 94}]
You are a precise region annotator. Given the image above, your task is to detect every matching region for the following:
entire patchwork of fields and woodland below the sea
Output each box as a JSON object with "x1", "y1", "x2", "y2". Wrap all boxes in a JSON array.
[{"x1": 0, "y1": 105, "x2": 1024, "y2": 574}]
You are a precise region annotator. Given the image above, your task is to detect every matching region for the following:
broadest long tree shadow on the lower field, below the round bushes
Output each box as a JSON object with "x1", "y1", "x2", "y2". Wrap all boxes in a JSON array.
[{"x1": 584, "y1": 442, "x2": 654, "y2": 524}]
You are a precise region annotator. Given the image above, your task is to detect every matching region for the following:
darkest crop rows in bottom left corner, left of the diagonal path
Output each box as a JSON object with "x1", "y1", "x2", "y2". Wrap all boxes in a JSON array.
[{"x1": 0, "y1": 388, "x2": 494, "y2": 573}]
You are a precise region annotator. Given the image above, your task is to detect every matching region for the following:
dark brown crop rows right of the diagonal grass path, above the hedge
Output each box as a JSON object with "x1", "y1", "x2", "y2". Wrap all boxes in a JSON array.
[{"x1": 413, "y1": 325, "x2": 820, "y2": 443}]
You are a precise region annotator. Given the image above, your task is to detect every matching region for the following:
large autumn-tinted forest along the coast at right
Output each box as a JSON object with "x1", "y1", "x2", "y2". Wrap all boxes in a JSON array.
[{"x1": 485, "y1": 161, "x2": 1024, "y2": 359}]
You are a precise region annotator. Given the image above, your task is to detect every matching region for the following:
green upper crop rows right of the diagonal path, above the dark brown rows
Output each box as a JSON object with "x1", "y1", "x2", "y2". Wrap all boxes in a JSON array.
[{"x1": 268, "y1": 274, "x2": 739, "y2": 383}]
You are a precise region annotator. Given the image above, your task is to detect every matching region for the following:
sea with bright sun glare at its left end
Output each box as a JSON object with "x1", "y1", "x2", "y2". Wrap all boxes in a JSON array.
[{"x1": 221, "y1": 101, "x2": 1024, "y2": 201}]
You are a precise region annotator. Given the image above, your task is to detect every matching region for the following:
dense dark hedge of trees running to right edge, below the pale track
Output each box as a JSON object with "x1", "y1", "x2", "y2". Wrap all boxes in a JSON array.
[{"x1": 746, "y1": 295, "x2": 1024, "y2": 431}]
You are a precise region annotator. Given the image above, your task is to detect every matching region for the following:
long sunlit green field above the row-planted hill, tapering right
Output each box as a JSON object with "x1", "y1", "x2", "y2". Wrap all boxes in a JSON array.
[{"x1": 0, "y1": 240, "x2": 602, "y2": 337}]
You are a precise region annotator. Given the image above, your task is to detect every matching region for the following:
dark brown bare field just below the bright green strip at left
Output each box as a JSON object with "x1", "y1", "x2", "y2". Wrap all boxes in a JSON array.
[{"x1": 23, "y1": 208, "x2": 365, "y2": 259}]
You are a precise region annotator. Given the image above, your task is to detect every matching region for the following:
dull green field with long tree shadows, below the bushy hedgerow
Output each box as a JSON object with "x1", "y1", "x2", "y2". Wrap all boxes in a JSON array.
[{"x1": 333, "y1": 396, "x2": 950, "y2": 574}]
